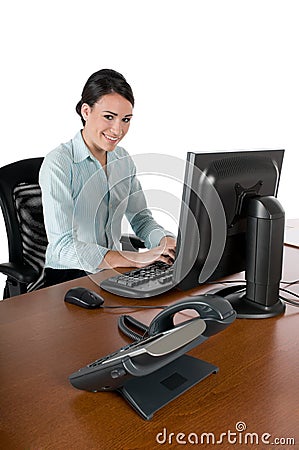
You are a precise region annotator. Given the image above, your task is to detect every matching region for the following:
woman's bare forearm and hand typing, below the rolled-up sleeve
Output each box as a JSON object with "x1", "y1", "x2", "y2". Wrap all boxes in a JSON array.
[{"x1": 99, "y1": 236, "x2": 176, "y2": 269}]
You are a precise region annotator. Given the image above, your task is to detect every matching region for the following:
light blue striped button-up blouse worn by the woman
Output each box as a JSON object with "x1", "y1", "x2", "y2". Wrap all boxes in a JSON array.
[{"x1": 39, "y1": 132, "x2": 171, "y2": 273}]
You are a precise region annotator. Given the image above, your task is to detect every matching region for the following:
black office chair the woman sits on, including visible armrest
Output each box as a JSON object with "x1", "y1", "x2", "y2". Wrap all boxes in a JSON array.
[{"x1": 0, "y1": 158, "x2": 144, "y2": 298}]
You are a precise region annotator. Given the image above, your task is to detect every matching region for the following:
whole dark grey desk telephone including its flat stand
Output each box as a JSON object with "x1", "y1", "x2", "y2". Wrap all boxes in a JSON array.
[{"x1": 69, "y1": 295, "x2": 236, "y2": 419}]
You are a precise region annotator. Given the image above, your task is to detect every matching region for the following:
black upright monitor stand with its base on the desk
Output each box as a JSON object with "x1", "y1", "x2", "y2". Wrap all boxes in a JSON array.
[{"x1": 208, "y1": 196, "x2": 285, "y2": 319}]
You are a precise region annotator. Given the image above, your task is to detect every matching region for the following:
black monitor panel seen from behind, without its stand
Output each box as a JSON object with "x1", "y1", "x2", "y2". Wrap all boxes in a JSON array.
[{"x1": 174, "y1": 150, "x2": 284, "y2": 318}]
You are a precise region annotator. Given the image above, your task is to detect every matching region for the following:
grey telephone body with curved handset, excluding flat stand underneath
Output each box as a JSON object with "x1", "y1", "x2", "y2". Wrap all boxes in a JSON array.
[{"x1": 70, "y1": 295, "x2": 236, "y2": 391}]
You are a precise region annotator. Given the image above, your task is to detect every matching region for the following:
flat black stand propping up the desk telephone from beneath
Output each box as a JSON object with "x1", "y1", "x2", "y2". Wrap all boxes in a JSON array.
[{"x1": 118, "y1": 355, "x2": 219, "y2": 420}]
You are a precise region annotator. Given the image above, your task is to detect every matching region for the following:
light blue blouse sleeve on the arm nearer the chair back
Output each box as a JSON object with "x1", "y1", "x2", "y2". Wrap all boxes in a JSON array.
[{"x1": 39, "y1": 151, "x2": 108, "y2": 272}]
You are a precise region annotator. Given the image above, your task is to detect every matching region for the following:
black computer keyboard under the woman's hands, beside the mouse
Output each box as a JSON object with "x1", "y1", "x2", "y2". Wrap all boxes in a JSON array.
[{"x1": 100, "y1": 261, "x2": 174, "y2": 298}]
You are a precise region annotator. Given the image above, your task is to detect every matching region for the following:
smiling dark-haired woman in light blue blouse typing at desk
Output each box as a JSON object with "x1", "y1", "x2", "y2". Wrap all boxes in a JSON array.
[{"x1": 40, "y1": 69, "x2": 176, "y2": 286}]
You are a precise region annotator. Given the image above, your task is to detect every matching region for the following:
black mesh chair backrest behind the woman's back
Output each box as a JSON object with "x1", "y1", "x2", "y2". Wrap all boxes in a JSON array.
[{"x1": 0, "y1": 158, "x2": 48, "y2": 291}]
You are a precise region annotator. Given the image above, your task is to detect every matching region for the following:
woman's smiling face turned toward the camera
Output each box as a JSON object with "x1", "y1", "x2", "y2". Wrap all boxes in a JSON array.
[{"x1": 81, "y1": 93, "x2": 133, "y2": 157}]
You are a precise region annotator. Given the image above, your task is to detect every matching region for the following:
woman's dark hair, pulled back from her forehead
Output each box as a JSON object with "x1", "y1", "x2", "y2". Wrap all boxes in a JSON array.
[{"x1": 76, "y1": 69, "x2": 134, "y2": 125}]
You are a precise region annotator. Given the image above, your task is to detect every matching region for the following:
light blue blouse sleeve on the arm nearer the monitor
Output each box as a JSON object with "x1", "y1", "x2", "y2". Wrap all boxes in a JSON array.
[{"x1": 126, "y1": 162, "x2": 175, "y2": 248}]
